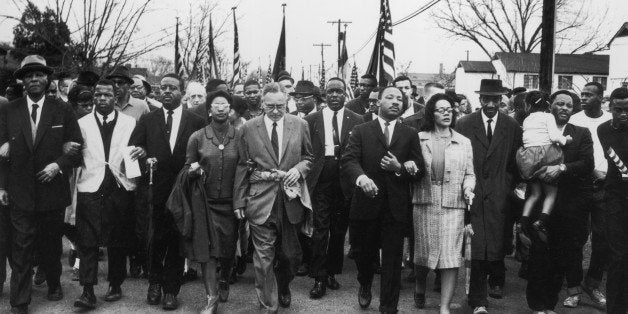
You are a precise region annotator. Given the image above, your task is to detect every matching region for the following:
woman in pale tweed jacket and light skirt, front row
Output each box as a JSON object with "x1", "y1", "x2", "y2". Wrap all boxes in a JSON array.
[{"x1": 412, "y1": 94, "x2": 475, "y2": 313}]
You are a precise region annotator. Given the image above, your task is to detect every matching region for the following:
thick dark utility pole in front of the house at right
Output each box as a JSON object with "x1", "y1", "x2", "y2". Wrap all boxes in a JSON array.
[{"x1": 539, "y1": 0, "x2": 556, "y2": 94}]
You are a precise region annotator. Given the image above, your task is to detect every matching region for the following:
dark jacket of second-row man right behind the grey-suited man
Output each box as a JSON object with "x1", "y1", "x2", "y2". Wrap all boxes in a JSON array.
[{"x1": 304, "y1": 110, "x2": 363, "y2": 196}]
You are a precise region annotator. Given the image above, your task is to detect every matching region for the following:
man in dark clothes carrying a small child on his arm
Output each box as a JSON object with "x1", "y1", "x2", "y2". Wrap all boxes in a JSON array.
[{"x1": 526, "y1": 90, "x2": 594, "y2": 311}]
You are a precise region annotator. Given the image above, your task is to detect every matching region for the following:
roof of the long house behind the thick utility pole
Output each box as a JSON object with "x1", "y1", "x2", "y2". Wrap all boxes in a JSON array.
[{"x1": 493, "y1": 52, "x2": 609, "y2": 75}]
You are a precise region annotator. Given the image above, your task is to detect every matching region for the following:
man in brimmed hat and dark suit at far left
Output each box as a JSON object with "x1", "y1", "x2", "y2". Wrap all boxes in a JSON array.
[{"x1": 0, "y1": 55, "x2": 83, "y2": 313}]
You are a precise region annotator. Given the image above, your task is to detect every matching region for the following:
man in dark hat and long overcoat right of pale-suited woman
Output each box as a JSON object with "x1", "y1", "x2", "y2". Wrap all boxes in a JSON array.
[{"x1": 456, "y1": 79, "x2": 521, "y2": 313}]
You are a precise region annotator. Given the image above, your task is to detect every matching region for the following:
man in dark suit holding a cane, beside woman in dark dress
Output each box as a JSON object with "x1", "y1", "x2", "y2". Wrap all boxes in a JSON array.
[{"x1": 129, "y1": 74, "x2": 205, "y2": 310}]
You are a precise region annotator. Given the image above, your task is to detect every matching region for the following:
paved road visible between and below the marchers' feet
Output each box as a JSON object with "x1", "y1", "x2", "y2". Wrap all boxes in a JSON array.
[{"x1": 0, "y1": 239, "x2": 603, "y2": 314}]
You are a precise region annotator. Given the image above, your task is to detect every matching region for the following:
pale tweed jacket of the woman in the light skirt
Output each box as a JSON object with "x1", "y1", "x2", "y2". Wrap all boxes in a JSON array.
[{"x1": 412, "y1": 130, "x2": 475, "y2": 209}]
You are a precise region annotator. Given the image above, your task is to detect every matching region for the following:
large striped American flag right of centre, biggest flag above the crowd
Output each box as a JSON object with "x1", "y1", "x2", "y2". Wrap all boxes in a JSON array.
[{"x1": 367, "y1": 0, "x2": 395, "y2": 86}]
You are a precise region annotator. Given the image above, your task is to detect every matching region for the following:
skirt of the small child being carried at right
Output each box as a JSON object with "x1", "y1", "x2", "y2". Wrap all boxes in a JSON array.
[{"x1": 516, "y1": 144, "x2": 563, "y2": 180}]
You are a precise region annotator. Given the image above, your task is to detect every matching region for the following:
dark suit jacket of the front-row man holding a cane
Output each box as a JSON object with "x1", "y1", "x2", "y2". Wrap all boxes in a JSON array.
[{"x1": 129, "y1": 110, "x2": 205, "y2": 206}]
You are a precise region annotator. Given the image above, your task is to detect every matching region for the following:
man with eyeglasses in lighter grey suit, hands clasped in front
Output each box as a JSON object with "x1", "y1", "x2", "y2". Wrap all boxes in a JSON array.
[{"x1": 233, "y1": 83, "x2": 312, "y2": 313}]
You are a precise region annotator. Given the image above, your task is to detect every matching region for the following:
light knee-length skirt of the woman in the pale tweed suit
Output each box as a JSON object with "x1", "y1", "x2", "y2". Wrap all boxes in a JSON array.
[{"x1": 413, "y1": 184, "x2": 464, "y2": 269}]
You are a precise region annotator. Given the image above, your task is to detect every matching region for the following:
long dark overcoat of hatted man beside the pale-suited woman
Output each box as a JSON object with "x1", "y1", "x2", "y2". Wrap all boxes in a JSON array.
[{"x1": 456, "y1": 110, "x2": 522, "y2": 261}]
